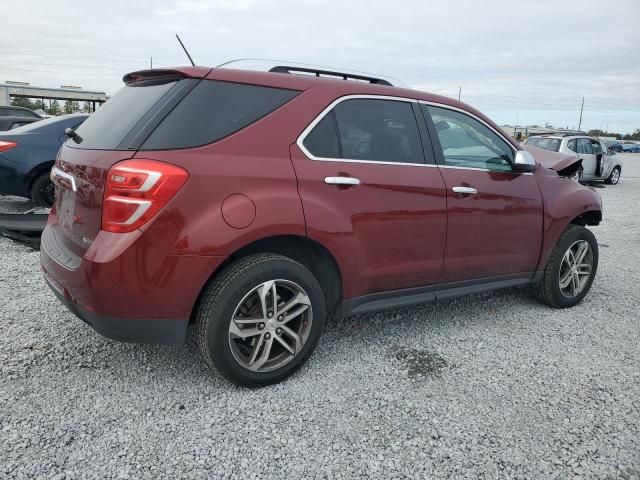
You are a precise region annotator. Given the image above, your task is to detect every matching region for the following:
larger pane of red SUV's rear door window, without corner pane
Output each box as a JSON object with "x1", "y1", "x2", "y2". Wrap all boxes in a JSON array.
[{"x1": 334, "y1": 99, "x2": 424, "y2": 163}]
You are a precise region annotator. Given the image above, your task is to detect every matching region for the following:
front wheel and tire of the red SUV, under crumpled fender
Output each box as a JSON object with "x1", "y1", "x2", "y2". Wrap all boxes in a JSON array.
[{"x1": 533, "y1": 225, "x2": 598, "y2": 308}]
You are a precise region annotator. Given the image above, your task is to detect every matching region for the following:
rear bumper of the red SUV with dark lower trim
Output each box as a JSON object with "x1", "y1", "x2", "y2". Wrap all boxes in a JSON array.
[{"x1": 40, "y1": 218, "x2": 223, "y2": 345}]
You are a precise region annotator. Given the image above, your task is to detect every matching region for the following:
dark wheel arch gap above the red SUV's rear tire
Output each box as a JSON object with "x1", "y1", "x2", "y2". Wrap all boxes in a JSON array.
[{"x1": 190, "y1": 235, "x2": 342, "y2": 323}]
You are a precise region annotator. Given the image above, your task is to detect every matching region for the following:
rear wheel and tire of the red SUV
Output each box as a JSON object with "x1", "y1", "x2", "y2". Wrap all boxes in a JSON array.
[{"x1": 196, "y1": 254, "x2": 326, "y2": 387}]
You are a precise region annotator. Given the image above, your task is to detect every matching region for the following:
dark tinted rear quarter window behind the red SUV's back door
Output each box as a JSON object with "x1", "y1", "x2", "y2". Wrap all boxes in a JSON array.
[{"x1": 141, "y1": 80, "x2": 299, "y2": 150}]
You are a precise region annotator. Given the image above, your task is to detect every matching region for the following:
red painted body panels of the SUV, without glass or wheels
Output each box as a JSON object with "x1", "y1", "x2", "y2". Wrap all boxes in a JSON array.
[{"x1": 41, "y1": 64, "x2": 601, "y2": 326}]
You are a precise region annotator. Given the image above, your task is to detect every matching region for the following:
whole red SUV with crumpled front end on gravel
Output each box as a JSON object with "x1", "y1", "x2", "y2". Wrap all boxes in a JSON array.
[{"x1": 41, "y1": 66, "x2": 602, "y2": 386}]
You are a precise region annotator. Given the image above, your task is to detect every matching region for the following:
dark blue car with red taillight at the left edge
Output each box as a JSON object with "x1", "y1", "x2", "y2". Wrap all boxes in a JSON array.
[{"x1": 0, "y1": 114, "x2": 89, "y2": 207}]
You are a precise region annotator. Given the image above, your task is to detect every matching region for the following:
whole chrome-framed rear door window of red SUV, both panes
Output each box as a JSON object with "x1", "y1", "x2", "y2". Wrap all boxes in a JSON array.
[{"x1": 303, "y1": 98, "x2": 424, "y2": 164}]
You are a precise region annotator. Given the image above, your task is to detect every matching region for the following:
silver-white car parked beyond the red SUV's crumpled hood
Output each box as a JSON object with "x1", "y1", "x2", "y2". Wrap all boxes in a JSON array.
[{"x1": 525, "y1": 135, "x2": 622, "y2": 185}]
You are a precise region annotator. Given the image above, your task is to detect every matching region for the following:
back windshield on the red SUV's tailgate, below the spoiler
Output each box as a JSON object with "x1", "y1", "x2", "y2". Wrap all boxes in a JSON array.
[{"x1": 71, "y1": 82, "x2": 176, "y2": 150}]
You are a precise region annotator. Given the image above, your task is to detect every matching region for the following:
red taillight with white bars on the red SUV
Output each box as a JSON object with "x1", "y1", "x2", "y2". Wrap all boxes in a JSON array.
[{"x1": 102, "y1": 159, "x2": 189, "y2": 233}]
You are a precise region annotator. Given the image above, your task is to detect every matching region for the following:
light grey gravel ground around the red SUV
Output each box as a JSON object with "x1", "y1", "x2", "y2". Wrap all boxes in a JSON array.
[{"x1": 0, "y1": 155, "x2": 640, "y2": 479}]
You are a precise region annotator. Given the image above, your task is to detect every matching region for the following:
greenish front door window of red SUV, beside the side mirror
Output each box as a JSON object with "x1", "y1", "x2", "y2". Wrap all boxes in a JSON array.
[{"x1": 422, "y1": 105, "x2": 513, "y2": 171}]
